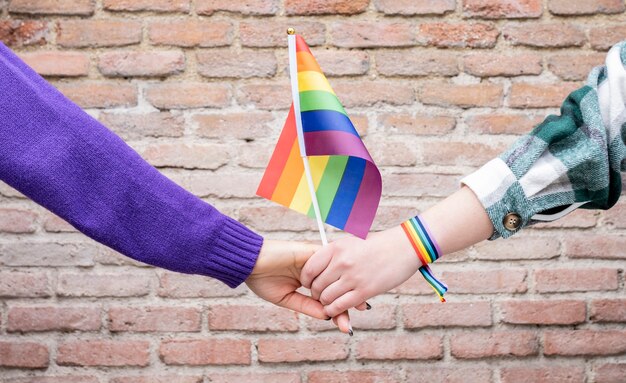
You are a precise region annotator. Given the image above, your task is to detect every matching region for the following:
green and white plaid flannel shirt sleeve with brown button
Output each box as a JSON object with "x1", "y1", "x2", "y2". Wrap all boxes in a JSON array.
[{"x1": 461, "y1": 41, "x2": 626, "y2": 239}]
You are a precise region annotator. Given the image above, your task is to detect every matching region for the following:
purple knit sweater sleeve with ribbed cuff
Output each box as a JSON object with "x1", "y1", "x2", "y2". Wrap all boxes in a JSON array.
[{"x1": 0, "y1": 43, "x2": 263, "y2": 287}]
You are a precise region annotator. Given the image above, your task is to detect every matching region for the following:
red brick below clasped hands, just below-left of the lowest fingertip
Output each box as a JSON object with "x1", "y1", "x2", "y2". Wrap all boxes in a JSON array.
[{"x1": 258, "y1": 336, "x2": 348, "y2": 363}]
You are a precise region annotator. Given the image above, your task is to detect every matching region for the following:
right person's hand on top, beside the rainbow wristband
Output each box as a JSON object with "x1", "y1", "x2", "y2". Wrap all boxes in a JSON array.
[{"x1": 300, "y1": 226, "x2": 422, "y2": 317}]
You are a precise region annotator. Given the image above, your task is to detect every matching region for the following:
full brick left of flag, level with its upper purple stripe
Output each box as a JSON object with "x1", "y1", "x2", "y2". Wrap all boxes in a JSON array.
[{"x1": 142, "y1": 143, "x2": 229, "y2": 169}]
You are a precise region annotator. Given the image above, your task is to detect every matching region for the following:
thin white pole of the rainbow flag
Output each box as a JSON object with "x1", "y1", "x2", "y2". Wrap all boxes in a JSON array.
[{"x1": 287, "y1": 28, "x2": 328, "y2": 246}]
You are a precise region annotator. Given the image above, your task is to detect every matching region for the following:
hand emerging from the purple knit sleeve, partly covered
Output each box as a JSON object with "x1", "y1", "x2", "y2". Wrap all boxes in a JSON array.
[{"x1": 246, "y1": 240, "x2": 351, "y2": 333}]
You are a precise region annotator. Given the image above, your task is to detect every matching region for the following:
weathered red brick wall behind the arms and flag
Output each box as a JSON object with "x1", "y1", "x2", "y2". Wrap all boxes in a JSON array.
[{"x1": 0, "y1": 0, "x2": 626, "y2": 383}]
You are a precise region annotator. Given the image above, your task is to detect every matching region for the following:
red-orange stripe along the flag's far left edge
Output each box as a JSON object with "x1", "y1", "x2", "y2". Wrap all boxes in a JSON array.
[{"x1": 256, "y1": 105, "x2": 302, "y2": 200}]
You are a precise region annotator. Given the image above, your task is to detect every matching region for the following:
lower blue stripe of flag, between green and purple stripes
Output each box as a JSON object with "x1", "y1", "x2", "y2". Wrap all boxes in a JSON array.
[{"x1": 326, "y1": 157, "x2": 365, "y2": 229}]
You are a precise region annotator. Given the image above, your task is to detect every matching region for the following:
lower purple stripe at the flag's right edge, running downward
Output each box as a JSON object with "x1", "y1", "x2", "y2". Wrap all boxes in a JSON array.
[{"x1": 343, "y1": 162, "x2": 382, "y2": 239}]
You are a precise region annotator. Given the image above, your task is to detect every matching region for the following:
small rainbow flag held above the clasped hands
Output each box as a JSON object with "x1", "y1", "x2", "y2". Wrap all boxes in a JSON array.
[{"x1": 257, "y1": 35, "x2": 382, "y2": 238}]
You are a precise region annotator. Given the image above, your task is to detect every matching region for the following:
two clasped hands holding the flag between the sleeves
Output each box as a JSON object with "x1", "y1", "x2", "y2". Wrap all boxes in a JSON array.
[{"x1": 246, "y1": 226, "x2": 421, "y2": 334}]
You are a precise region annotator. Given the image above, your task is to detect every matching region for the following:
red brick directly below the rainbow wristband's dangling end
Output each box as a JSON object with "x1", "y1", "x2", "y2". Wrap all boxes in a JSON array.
[{"x1": 402, "y1": 302, "x2": 492, "y2": 328}]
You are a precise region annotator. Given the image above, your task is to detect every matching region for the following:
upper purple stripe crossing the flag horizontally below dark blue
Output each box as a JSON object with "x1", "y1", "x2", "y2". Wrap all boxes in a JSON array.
[{"x1": 304, "y1": 130, "x2": 374, "y2": 162}]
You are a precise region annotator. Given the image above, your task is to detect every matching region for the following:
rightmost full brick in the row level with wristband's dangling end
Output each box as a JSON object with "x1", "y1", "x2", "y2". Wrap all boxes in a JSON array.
[{"x1": 535, "y1": 268, "x2": 618, "y2": 293}]
